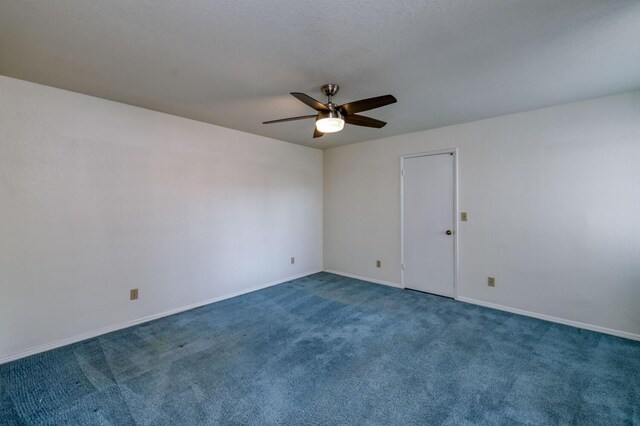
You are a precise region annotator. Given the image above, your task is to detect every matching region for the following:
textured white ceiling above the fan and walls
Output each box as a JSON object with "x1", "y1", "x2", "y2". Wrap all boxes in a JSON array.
[{"x1": 0, "y1": 0, "x2": 640, "y2": 148}]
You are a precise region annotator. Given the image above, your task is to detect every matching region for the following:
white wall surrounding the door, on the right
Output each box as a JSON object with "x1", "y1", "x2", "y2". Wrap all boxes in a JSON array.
[{"x1": 324, "y1": 92, "x2": 640, "y2": 338}]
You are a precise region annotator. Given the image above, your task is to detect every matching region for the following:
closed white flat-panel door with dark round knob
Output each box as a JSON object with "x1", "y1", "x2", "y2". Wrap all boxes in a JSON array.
[{"x1": 403, "y1": 153, "x2": 455, "y2": 297}]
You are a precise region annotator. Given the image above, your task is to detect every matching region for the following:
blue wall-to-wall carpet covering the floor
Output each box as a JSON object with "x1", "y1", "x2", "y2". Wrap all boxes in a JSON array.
[{"x1": 0, "y1": 273, "x2": 640, "y2": 425}]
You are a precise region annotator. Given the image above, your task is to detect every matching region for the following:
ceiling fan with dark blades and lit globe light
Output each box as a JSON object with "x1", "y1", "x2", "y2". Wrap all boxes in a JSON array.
[{"x1": 262, "y1": 84, "x2": 397, "y2": 138}]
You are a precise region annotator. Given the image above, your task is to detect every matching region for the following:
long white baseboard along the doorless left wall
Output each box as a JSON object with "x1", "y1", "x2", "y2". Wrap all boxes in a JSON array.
[{"x1": 0, "y1": 269, "x2": 322, "y2": 364}]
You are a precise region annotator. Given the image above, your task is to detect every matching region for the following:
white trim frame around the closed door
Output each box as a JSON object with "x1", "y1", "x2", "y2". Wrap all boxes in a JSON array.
[{"x1": 400, "y1": 148, "x2": 459, "y2": 300}]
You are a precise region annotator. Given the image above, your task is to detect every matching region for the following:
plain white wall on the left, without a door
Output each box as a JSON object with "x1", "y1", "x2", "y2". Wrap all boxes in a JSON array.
[{"x1": 0, "y1": 77, "x2": 323, "y2": 361}]
